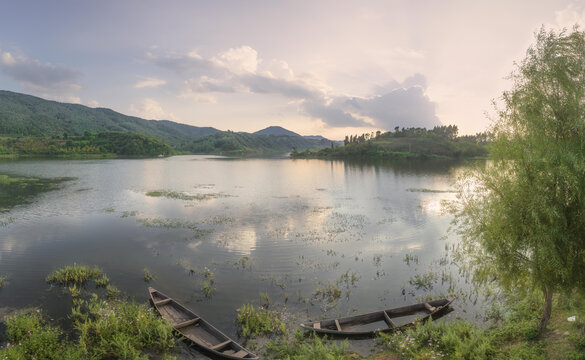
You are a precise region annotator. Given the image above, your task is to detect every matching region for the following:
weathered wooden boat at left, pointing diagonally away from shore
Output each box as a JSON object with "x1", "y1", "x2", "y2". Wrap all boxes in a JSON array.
[{"x1": 148, "y1": 287, "x2": 258, "y2": 359}]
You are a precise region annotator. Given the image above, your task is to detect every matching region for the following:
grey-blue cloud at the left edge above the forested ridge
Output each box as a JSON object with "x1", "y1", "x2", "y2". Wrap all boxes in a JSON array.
[{"x1": 0, "y1": 49, "x2": 81, "y2": 97}]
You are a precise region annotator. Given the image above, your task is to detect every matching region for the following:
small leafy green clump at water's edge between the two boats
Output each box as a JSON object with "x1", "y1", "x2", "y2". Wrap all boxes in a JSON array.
[{"x1": 236, "y1": 304, "x2": 287, "y2": 337}]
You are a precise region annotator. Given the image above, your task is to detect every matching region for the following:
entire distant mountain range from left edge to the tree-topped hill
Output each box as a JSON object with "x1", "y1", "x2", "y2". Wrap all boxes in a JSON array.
[{"x1": 0, "y1": 90, "x2": 331, "y2": 155}]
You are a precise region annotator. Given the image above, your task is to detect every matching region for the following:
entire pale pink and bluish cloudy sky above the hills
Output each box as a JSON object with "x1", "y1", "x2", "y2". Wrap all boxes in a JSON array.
[{"x1": 0, "y1": 0, "x2": 585, "y2": 139}]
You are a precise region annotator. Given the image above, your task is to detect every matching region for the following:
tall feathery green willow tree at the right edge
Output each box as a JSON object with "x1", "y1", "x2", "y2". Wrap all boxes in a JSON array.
[{"x1": 456, "y1": 27, "x2": 585, "y2": 332}]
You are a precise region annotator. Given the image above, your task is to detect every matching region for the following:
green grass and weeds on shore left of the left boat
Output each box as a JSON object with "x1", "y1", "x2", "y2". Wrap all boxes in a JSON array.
[{"x1": 0, "y1": 265, "x2": 176, "y2": 360}]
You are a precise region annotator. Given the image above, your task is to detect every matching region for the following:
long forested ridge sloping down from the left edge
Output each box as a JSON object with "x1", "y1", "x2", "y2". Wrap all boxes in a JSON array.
[{"x1": 0, "y1": 90, "x2": 219, "y2": 148}]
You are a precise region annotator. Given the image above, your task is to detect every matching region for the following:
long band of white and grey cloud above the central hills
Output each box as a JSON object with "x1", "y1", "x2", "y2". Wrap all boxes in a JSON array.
[{"x1": 151, "y1": 46, "x2": 440, "y2": 130}]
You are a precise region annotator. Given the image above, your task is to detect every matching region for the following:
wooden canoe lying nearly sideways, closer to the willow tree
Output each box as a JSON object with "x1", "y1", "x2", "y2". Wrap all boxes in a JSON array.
[{"x1": 301, "y1": 298, "x2": 454, "y2": 337}]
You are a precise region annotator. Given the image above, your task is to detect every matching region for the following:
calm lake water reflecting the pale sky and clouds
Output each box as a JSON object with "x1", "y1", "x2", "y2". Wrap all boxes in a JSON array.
[{"x1": 0, "y1": 156, "x2": 480, "y2": 356}]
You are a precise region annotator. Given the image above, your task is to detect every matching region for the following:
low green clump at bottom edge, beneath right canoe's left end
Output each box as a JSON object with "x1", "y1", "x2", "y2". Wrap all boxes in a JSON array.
[{"x1": 266, "y1": 330, "x2": 355, "y2": 360}]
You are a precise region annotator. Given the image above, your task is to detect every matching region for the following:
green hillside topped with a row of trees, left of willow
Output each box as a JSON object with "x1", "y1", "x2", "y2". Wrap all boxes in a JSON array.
[{"x1": 291, "y1": 125, "x2": 489, "y2": 159}]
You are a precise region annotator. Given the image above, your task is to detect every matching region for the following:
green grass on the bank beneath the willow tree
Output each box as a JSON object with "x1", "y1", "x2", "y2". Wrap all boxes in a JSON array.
[{"x1": 379, "y1": 293, "x2": 585, "y2": 360}]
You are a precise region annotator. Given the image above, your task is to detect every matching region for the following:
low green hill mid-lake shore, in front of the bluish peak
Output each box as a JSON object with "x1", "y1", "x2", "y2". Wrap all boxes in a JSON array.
[{"x1": 183, "y1": 131, "x2": 331, "y2": 156}]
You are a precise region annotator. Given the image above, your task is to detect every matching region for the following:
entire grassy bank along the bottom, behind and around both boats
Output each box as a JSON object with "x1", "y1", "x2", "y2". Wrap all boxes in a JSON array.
[{"x1": 0, "y1": 272, "x2": 585, "y2": 360}]
